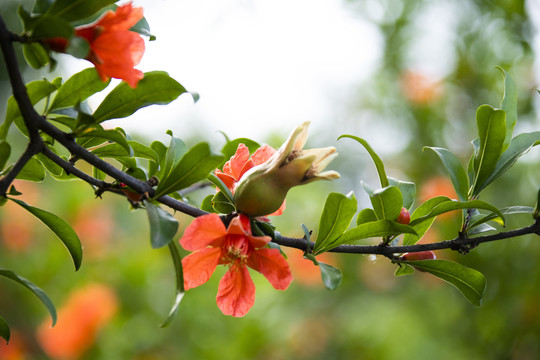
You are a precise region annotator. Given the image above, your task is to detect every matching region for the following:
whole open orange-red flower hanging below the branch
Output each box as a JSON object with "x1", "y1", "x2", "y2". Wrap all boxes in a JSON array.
[{"x1": 180, "y1": 214, "x2": 292, "y2": 317}]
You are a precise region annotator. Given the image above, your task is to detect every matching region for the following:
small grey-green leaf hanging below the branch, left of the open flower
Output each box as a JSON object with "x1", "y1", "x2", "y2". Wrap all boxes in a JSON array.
[{"x1": 144, "y1": 201, "x2": 178, "y2": 249}]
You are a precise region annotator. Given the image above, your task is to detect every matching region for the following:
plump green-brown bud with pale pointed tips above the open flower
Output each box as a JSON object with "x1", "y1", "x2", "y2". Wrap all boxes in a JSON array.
[{"x1": 234, "y1": 122, "x2": 339, "y2": 216}]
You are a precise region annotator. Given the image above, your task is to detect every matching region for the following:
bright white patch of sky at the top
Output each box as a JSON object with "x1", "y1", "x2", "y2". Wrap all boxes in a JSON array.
[{"x1": 64, "y1": 0, "x2": 381, "y2": 141}]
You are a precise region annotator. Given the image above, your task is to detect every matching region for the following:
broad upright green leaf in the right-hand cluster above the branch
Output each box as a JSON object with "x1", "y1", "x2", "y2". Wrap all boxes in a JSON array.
[{"x1": 472, "y1": 105, "x2": 506, "y2": 197}]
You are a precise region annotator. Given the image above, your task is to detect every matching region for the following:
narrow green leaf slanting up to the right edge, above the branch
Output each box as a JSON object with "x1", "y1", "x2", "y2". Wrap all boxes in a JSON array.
[{"x1": 478, "y1": 131, "x2": 540, "y2": 191}]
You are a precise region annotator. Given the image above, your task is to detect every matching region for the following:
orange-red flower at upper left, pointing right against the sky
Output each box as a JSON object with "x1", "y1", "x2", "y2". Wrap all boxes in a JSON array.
[{"x1": 75, "y1": 3, "x2": 144, "y2": 88}]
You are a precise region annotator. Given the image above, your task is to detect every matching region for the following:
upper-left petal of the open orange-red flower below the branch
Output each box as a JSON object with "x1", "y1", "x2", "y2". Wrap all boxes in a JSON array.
[{"x1": 180, "y1": 214, "x2": 227, "y2": 251}]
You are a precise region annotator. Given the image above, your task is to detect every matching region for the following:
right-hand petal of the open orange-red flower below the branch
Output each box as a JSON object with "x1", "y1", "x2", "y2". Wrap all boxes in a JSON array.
[{"x1": 248, "y1": 248, "x2": 293, "y2": 290}]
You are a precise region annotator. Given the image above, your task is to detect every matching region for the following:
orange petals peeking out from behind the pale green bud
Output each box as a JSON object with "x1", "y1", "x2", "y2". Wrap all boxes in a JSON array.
[{"x1": 216, "y1": 144, "x2": 285, "y2": 216}]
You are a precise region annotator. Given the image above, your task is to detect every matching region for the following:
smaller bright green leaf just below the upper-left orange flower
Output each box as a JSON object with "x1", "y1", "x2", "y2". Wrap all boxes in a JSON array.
[{"x1": 49, "y1": 67, "x2": 110, "y2": 111}]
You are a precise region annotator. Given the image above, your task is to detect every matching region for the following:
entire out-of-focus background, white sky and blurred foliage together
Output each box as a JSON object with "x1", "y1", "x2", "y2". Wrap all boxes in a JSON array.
[{"x1": 0, "y1": 0, "x2": 540, "y2": 360}]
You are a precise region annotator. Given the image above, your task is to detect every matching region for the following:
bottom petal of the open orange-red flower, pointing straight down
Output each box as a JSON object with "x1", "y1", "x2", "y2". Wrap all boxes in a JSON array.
[{"x1": 216, "y1": 266, "x2": 255, "y2": 317}]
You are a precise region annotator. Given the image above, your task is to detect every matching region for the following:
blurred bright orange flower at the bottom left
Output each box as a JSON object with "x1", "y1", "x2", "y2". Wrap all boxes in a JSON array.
[{"x1": 37, "y1": 284, "x2": 117, "y2": 359}]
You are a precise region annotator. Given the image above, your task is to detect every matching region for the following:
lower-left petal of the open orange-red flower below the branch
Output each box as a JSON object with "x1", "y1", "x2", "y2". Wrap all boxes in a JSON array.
[{"x1": 182, "y1": 248, "x2": 221, "y2": 290}]
